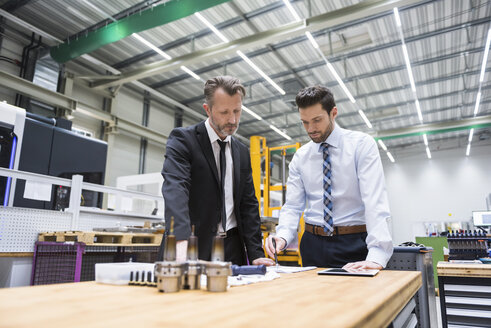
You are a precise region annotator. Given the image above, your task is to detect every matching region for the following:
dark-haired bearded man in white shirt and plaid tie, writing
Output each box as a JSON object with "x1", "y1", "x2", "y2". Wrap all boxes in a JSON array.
[{"x1": 265, "y1": 86, "x2": 393, "y2": 271}]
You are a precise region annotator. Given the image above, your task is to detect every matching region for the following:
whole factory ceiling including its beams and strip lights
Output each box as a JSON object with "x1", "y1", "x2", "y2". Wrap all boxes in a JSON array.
[{"x1": 0, "y1": 0, "x2": 491, "y2": 159}]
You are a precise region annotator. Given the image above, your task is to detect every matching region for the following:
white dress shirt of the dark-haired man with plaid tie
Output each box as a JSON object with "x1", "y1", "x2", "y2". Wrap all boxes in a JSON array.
[{"x1": 276, "y1": 125, "x2": 393, "y2": 267}]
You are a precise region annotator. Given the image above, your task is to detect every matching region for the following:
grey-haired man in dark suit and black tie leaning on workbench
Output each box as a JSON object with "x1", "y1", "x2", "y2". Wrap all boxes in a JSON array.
[{"x1": 162, "y1": 76, "x2": 273, "y2": 265}]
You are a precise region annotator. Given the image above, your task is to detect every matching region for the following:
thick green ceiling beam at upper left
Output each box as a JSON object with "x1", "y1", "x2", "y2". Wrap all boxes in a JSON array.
[{"x1": 50, "y1": 0, "x2": 230, "y2": 63}]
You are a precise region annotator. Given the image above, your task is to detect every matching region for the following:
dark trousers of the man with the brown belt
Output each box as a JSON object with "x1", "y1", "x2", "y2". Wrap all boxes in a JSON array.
[{"x1": 300, "y1": 232, "x2": 368, "y2": 268}]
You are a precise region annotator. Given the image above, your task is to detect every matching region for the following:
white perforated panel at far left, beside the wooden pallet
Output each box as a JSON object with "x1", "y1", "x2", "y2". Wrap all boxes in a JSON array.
[{"x1": 0, "y1": 207, "x2": 72, "y2": 253}]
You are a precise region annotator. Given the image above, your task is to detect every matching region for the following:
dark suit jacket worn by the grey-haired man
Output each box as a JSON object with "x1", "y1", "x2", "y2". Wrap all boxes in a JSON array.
[{"x1": 162, "y1": 121, "x2": 264, "y2": 263}]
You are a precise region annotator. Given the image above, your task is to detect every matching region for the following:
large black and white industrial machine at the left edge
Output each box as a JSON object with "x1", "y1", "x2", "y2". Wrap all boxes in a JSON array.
[{"x1": 0, "y1": 103, "x2": 107, "y2": 210}]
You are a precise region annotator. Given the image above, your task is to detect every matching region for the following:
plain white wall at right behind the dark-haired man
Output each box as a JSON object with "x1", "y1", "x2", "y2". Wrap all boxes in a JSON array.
[{"x1": 382, "y1": 145, "x2": 491, "y2": 244}]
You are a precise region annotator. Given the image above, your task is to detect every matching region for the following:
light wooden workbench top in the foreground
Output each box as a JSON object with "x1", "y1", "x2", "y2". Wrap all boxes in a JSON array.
[{"x1": 0, "y1": 270, "x2": 421, "y2": 328}]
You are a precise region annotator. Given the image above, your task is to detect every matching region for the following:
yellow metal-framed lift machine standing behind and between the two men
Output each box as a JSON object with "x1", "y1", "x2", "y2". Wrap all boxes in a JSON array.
[{"x1": 250, "y1": 136, "x2": 305, "y2": 266}]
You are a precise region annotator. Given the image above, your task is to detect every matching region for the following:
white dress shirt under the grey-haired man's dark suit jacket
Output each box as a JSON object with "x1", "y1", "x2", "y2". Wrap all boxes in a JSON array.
[{"x1": 205, "y1": 118, "x2": 237, "y2": 232}]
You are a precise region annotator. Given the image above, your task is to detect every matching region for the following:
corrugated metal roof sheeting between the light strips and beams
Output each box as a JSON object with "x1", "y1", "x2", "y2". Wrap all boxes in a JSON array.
[{"x1": 0, "y1": 0, "x2": 491, "y2": 156}]
